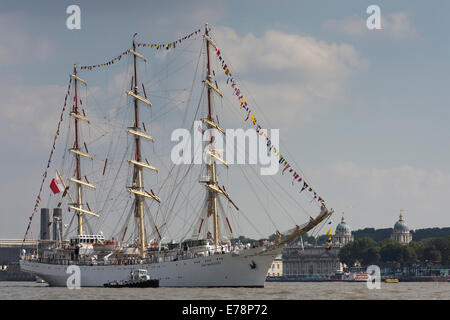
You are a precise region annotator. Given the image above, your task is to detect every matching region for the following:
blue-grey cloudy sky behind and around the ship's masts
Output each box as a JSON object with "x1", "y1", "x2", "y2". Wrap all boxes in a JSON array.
[{"x1": 0, "y1": 0, "x2": 450, "y2": 238}]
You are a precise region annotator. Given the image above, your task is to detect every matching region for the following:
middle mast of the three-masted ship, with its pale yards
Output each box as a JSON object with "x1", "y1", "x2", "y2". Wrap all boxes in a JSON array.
[{"x1": 127, "y1": 34, "x2": 160, "y2": 258}]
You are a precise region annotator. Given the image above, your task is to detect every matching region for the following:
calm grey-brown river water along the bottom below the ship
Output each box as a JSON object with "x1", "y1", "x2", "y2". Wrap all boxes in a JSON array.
[{"x1": 0, "y1": 282, "x2": 450, "y2": 300}]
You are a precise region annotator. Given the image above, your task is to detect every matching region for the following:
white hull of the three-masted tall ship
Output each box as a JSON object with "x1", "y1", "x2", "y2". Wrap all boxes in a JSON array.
[{"x1": 20, "y1": 248, "x2": 282, "y2": 287}]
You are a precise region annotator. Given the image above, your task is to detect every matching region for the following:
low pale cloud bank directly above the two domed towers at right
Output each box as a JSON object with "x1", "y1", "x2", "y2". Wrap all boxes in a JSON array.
[{"x1": 313, "y1": 162, "x2": 450, "y2": 229}]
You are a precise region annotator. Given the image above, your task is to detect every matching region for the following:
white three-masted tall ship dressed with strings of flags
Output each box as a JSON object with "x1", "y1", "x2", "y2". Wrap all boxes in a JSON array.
[{"x1": 20, "y1": 25, "x2": 333, "y2": 287}]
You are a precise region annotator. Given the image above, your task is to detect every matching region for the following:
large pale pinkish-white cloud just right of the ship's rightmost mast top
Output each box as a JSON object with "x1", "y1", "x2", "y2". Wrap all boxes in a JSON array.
[{"x1": 213, "y1": 27, "x2": 368, "y2": 126}]
